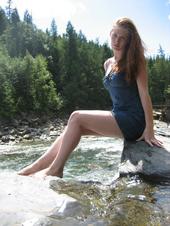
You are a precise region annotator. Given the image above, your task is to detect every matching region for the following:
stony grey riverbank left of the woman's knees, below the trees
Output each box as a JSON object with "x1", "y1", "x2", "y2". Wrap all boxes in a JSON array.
[{"x1": 0, "y1": 116, "x2": 68, "y2": 145}]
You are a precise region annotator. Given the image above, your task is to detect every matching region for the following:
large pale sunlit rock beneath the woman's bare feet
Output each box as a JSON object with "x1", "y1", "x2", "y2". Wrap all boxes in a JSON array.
[{"x1": 0, "y1": 171, "x2": 107, "y2": 226}]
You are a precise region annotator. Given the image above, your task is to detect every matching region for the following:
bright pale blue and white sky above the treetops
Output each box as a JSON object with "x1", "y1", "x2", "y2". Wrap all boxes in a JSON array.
[{"x1": 0, "y1": 0, "x2": 170, "y2": 55}]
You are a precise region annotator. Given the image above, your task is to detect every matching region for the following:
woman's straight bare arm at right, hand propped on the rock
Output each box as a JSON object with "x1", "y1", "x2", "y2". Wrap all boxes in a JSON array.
[{"x1": 136, "y1": 67, "x2": 162, "y2": 147}]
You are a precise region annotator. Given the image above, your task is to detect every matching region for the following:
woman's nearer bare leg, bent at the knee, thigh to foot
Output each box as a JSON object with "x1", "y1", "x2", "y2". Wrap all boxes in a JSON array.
[{"x1": 38, "y1": 111, "x2": 123, "y2": 177}]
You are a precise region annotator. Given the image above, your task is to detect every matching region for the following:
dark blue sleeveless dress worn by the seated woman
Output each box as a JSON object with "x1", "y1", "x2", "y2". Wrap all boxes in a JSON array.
[{"x1": 103, "y1": 68, "x2": 145, "y2": 141}]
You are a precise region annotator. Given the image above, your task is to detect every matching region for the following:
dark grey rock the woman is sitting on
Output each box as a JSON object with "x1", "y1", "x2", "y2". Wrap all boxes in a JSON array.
[{"x1": 119, "y1": 140, "x2": 170, "y2": 182}]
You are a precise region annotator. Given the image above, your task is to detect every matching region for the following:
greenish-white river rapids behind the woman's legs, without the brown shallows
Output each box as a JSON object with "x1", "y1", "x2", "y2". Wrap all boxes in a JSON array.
[{"x1": 0, "y1": 137, "x2": 123, "y2": 183}]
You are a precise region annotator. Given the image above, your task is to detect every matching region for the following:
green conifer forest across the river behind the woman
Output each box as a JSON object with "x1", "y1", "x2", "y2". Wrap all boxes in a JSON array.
[{"x1": 0, "y1": 1, "x2": 170, "y2": 118}]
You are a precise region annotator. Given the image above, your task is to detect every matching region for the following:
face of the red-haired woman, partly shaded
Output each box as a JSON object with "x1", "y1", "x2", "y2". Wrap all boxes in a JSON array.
[{"x1": 110, "y1": 26, "x2": 129, "y2": 52}]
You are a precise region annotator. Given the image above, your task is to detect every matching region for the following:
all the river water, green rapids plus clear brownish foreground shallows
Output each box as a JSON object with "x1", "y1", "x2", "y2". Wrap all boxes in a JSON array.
[{"x1": 0, "y1": 137, "x2": 170, "y2": 226}]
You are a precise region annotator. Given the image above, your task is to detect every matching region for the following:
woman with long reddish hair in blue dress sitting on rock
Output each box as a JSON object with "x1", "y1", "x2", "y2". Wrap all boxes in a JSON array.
[{"x1": 19, "y1": 18, "x2": 161, "y2": 177}]
